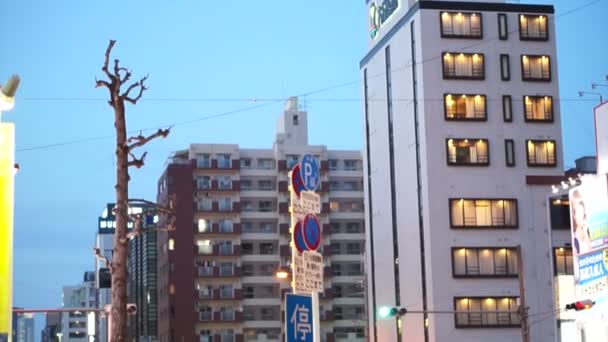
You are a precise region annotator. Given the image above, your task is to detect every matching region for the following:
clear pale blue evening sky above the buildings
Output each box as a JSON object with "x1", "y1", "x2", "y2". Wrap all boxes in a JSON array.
[{"x1": 0, "y1": 0, "x2": 608, "y2": 336}]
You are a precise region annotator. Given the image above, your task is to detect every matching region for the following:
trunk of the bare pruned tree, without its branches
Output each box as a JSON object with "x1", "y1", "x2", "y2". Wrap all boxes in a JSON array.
[{"x1": 110, "y1": 96, "x2": 129, "y2": 342}]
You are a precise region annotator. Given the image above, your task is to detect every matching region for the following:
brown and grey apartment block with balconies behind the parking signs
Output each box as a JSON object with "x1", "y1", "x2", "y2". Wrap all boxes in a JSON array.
[{"x1": 158, "y1": 98, "x2": 366, "y2": 342}]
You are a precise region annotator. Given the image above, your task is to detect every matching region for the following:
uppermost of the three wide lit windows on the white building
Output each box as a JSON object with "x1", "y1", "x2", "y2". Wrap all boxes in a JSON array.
[{"x1": 450, "y1": 198, "x2": 517, "y2": 228}]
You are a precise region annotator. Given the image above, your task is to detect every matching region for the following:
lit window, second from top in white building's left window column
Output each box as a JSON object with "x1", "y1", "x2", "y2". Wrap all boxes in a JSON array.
[{"x1": 443, "y1": 52, "x2": 485, "y2": 80}]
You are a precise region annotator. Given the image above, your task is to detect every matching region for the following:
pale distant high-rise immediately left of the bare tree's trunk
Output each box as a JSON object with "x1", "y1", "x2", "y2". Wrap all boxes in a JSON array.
[{"x1": 61, "y1": 271, "x2": 97, "y2": 342}]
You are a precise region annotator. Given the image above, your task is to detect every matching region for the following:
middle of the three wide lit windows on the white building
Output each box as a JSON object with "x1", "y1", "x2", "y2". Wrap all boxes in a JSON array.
[{"x1": 452, "y1": 247, "x2": 518, "y2": 278}]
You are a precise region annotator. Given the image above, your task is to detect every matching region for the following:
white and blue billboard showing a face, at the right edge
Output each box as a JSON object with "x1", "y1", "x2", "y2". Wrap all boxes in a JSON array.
[{"x1": 569, "y1": 175, "x2": 608, "y2": 299}]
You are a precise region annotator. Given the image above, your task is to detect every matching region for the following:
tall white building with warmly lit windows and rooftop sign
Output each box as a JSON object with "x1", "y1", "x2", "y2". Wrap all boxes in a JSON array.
[{"x1": 360, "y1": 0, "x2": 564, "y2": 342}]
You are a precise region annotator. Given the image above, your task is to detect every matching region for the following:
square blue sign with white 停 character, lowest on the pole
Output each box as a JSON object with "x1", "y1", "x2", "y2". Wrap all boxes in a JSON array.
[{"x1": 285, "y1": 293, "x2": 313, "y2": 342}]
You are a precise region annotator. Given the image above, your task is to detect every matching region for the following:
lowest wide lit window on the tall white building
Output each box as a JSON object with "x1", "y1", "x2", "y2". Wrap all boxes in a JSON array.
[{"x1": 454, "y1": 297, "x2": 520, "y2": 328}]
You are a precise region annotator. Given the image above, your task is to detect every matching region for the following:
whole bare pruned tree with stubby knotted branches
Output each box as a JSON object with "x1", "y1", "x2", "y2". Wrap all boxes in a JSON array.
[{"x1": 95, "y1": 40, "x2": 174, "y2": 342}]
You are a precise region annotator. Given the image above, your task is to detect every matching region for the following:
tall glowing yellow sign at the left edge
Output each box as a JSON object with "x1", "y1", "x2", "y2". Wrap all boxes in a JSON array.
[{"x1": 0, "y1": 123, "x2": 15, "y2": 340}]
